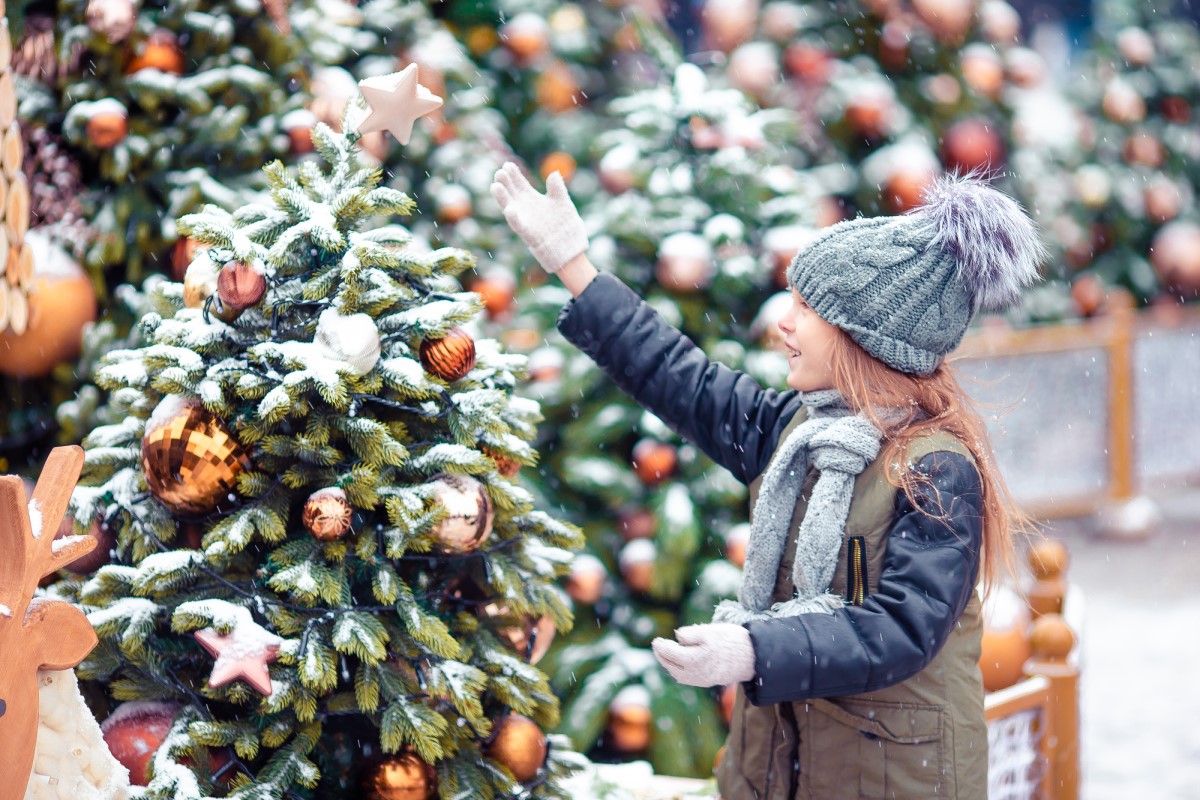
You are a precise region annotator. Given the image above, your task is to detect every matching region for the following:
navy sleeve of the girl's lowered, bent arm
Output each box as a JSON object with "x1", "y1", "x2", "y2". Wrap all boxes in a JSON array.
[{"x1": 743, "y1": 451, "x2": 983, "y2": 705}]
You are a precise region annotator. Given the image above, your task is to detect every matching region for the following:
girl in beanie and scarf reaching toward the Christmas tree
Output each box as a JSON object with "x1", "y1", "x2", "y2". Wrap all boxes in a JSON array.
[{"x1": 492, "y1": 163, "x2": 1043, "y2": 800}]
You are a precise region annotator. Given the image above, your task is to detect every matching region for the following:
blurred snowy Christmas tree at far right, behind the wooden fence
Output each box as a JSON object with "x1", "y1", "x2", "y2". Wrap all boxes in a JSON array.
[{"x1": 1048, "y1": 0, "x2": 1200, "y2": 315}]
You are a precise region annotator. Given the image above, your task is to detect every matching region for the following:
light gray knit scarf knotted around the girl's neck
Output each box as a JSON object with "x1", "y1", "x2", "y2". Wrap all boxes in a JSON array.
[{"x1": 713, "y1": 390, "x2": 883, "y2": 625}]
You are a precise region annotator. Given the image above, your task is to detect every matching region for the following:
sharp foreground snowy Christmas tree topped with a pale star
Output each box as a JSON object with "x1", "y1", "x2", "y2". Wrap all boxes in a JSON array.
[{"x1": 64, "y1": 84, "x2": 578, "y2": 798}]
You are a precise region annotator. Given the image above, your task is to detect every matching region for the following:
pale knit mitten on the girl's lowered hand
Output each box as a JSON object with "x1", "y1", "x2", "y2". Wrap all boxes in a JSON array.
[{"x1": 650, "y1": 622, "x2": 754, "y2": 686}]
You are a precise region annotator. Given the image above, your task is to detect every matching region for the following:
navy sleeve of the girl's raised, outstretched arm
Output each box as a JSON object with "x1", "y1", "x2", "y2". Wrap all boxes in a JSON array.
[{"x1": 558, "y1": 273, "x2": 800, "y2": 483}]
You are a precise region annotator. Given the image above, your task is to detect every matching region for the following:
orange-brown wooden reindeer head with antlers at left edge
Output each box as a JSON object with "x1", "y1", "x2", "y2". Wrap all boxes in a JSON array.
[{"x1": 0, "y1": 446, "x2": 111, "y2": 800}]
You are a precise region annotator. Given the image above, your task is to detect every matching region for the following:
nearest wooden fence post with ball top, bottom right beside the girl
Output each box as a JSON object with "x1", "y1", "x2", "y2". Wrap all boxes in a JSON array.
[{"x1": 1025, "y1": 613, "x2": 1079, "y2": 800}]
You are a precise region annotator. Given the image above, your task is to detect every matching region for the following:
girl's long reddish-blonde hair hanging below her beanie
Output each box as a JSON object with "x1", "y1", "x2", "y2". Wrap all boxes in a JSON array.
[{"x1": 830, "y1": 327, "x2": 1033, "y2": 591}]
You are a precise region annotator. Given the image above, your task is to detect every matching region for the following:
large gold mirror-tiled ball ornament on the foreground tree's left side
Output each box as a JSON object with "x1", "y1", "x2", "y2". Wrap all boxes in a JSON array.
[{"x1": 142, "y1": 395, "x2": 251, "y2": 516}]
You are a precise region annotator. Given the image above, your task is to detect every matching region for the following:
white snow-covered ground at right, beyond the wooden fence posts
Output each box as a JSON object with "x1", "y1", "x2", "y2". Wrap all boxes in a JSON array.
[{"x1": 1056, "y1": 491, "x2": 1200, "y2": 800}]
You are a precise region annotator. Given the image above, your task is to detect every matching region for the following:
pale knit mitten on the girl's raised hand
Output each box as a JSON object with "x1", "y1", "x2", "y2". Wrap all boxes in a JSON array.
[{"x1": 492, "y1": 161, "x2": 588, "y2": 272}]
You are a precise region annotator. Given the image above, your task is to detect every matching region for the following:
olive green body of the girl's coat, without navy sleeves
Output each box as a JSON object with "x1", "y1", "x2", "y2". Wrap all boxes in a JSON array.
[{"x1": 716, "y1": 410, "x2": 988, "y2": 800}]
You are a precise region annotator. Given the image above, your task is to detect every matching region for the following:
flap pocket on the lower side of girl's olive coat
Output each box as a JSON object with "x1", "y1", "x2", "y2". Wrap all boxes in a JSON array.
[{"x1": 800, "y1": 698, "x2": 954, "y2": 800}]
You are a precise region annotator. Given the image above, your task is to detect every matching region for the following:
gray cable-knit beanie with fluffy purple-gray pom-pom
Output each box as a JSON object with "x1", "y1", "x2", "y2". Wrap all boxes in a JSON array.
[{"x1": 787, "y1": 175, "x2": 1045, "y2": 375}]
